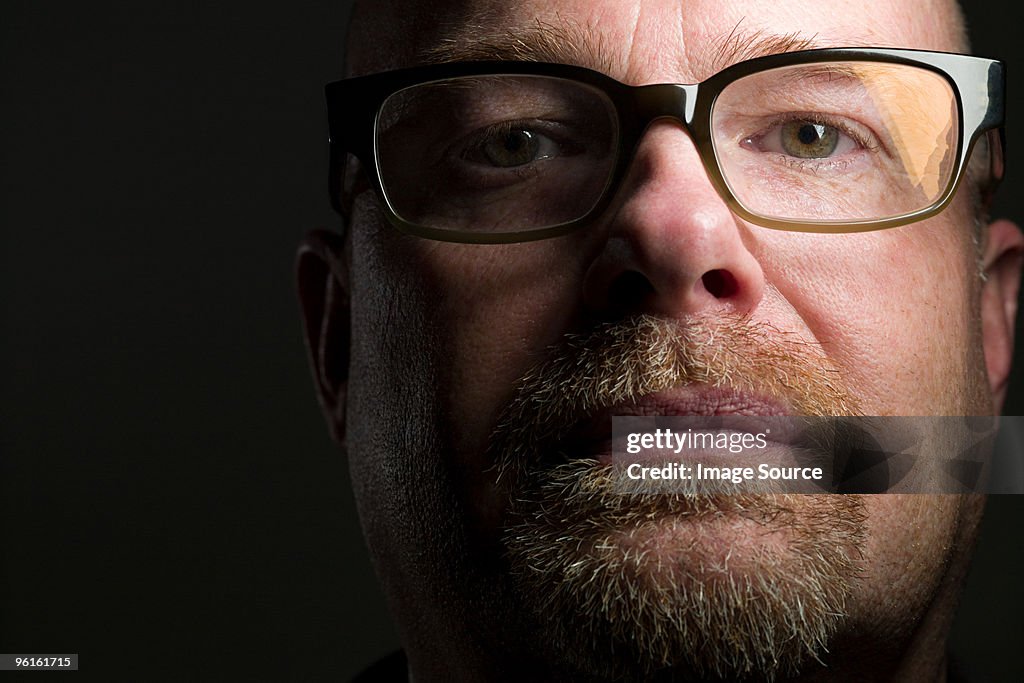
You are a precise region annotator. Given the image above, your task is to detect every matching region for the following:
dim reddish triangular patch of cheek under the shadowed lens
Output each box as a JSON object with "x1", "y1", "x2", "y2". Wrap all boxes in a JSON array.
[{"x1": 414, "y1": 240, "x2": 582, "y2": 464}]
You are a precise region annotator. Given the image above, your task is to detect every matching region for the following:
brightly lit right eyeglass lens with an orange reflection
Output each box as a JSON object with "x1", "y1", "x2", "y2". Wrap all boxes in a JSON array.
[{"x1": 712, "y1": 61, "x2": 959, "y2": 223}]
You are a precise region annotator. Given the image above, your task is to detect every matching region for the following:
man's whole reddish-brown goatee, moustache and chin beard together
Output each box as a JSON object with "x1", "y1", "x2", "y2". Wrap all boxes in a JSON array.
[{"x1": 492, "y1": 316, "x2": 865, "y2": 680}]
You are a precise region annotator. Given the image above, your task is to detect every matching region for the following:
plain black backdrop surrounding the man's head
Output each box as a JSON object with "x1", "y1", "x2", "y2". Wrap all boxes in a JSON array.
[{"x1": 0, "y1": 0, "x2": 1024, "y2": 680}]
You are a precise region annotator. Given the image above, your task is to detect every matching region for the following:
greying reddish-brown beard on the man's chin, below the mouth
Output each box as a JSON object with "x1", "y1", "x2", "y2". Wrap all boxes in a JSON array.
[{"x1": 505, "y1": 460, "x2": 864, "y2": 680}]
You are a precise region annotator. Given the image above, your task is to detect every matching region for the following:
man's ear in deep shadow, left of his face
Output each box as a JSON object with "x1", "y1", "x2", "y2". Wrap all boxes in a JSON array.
[{"x1": 295, "y1": 230, "x2": 350, "y2": 445}]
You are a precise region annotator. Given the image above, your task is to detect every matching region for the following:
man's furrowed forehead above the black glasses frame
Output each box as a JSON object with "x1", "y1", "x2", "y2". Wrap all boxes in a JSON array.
[{"x1": 350, "y1": 0, "x2": 965, "y2": 83}]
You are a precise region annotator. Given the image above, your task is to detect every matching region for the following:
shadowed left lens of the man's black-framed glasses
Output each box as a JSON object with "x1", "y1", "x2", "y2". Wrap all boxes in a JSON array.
[{"x1": 376, "y1": 75, "x2": 617, "y2": 232}]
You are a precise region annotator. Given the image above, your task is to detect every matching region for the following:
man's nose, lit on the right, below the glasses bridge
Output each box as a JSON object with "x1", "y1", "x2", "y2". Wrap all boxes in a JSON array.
[{"x1": 584, "y1": 119, "x2": 765, "y2": 319}]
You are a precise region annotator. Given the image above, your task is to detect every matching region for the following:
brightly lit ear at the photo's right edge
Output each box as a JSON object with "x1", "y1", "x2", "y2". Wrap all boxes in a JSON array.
[{"x1": 981, "y1": 220, "x2": 1024, "y2": 414}]
